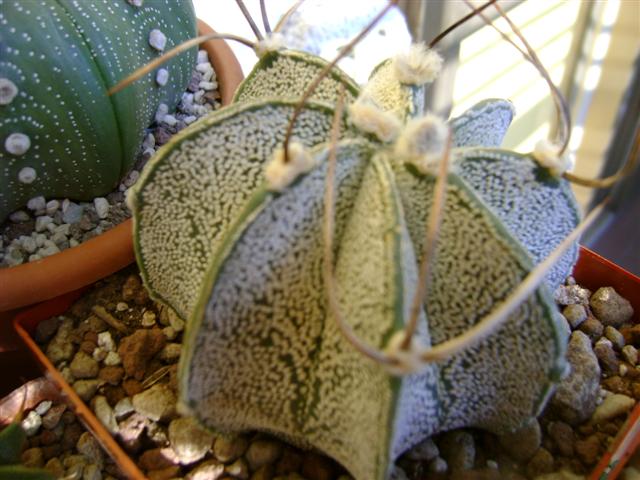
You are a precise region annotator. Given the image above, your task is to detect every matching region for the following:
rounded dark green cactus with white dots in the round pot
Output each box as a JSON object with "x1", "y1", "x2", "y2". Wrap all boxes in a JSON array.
[{"x1": 0, "y1": 0, "x2": 195, "y2": 221}]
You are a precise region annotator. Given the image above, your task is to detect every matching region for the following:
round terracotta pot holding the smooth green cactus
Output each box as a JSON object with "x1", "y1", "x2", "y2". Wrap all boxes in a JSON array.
[{"x1": 0, "y1": 20, "x2": 243, "y2": 316}]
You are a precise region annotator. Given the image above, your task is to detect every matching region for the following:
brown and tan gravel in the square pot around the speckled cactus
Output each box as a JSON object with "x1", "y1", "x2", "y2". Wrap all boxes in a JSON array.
[{"x1": 36, "y1": 267, "x2": 640, "y2": 480}]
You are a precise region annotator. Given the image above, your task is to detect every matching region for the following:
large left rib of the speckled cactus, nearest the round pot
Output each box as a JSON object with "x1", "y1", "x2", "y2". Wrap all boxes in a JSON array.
[{"x1": 129, "y1": 99, "x2": 348, "y2": 318}]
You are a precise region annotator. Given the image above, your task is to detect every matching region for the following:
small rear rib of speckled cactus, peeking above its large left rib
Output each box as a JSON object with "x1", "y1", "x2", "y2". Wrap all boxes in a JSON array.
[{"x1": 233, "y1": 50, "x2": 359, "y2": 104}]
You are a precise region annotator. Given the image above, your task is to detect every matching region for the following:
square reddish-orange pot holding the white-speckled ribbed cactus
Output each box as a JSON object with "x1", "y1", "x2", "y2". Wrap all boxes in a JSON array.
[{"x1": 7, "y1": 247, "x2": 640, "y2": 480}]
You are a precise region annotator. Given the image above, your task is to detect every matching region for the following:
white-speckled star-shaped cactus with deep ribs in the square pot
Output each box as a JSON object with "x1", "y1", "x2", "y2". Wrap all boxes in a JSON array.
[{"x1": 129, "y1": 43, "x2": 578, "y2": 480}]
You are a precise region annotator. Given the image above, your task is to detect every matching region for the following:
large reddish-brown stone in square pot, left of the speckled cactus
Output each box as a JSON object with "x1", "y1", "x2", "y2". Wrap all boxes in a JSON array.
[{"x1": 118, "y1": 328, "x2": 167, "y2": 380}]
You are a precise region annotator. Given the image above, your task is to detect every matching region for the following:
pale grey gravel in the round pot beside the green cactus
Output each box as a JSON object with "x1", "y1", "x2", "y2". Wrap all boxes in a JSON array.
[{"x1": 0, "y1": 50, "x2": 220, "y2": 268}]
